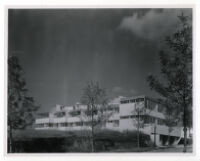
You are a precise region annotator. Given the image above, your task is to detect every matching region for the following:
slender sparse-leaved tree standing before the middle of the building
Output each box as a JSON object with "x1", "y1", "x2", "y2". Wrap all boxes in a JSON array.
[{"x1": 81, "y1": 82, "x2": 109, "y2": 152}]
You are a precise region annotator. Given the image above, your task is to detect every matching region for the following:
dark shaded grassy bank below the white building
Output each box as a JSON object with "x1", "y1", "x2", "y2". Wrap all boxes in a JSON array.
[{"x1": 9, "y1": 130, "x2": 152, "y2": 153}]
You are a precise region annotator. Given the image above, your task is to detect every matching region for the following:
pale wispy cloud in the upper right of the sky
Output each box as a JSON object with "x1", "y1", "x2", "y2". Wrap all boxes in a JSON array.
[{"x1": 119, "y1": 9, "x2": 191, "y2": 41}]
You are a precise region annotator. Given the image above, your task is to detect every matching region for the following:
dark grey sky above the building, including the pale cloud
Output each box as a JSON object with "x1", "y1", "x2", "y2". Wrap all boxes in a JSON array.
[{"x1": 8, "y1": 9, "x2": 191, "y2": 111}]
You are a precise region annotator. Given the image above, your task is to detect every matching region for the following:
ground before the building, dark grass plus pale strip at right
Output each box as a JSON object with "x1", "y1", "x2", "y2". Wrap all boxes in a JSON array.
[{"x1": 10, "y1": 130, "x2": 192, "y2": 153}]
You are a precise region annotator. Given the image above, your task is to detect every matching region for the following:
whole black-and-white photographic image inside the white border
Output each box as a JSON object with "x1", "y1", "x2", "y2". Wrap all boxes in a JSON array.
[{"x1": 5, "y1": 7, "x2": 192, "y2": 155}]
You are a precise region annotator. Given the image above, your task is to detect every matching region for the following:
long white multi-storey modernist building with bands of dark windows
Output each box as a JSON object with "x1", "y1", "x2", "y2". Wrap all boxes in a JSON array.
[{"x1": 35, "y1": 96, "x2": 186, "y2": 145}]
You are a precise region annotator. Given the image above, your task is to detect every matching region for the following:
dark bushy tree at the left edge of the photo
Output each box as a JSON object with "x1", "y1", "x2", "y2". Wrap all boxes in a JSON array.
[{"x1": 8, "y1": 56, "x2": 39, "y2": 152}]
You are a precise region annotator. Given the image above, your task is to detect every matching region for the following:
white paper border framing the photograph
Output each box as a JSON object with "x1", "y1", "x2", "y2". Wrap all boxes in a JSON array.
[{"x1": 0, "y1": 0, "x2": 200, "y2": 161}]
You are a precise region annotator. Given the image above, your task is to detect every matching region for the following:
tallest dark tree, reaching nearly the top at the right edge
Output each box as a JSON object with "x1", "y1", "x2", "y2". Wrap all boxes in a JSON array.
[{"x1": 147, "y1": 13, "x2": 192, "y2": 152}]
